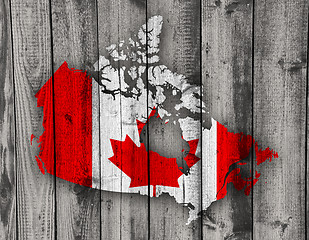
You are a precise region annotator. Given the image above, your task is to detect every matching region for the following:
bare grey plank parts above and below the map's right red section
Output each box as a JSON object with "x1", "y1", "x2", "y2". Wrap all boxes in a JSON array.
[{"x1": 202, "y1": 0, "x2": 253, "y2": 239}]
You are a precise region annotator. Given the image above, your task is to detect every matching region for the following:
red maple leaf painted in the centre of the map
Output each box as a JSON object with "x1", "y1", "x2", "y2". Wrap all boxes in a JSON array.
[{"x1": 109, "y1": 110, "x2": 200, "y2": 196}]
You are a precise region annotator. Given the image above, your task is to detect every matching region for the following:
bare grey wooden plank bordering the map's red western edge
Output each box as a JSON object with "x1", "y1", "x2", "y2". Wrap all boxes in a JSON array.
[{"x1": 11, "y1": 0, "x2": 55, "y2": 239}]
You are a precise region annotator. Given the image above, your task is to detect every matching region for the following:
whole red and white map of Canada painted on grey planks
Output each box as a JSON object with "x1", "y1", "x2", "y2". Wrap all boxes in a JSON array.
[{"x1": 31, "y1": 16, "x2": 278, "y2": 223}]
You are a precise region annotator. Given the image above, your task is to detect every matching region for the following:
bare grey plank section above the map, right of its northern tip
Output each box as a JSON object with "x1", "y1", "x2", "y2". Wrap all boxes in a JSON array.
[{"x1": 147, "y1": 0, "x2": 201, "y2": 83}]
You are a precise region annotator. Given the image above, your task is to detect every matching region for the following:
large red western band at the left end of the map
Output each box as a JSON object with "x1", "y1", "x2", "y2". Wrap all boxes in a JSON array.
[{"x1": 35, "y1": 62, "x2": 92, "y2": 187}]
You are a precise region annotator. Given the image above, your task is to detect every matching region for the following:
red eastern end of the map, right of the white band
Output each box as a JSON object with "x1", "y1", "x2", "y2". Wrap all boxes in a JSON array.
[{"x1": 217, "y1": 123, "x2": 278, "y2": 199}]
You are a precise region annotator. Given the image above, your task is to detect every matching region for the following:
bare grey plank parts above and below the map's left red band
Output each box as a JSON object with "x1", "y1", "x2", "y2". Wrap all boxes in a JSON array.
[{"x1": 51, "y1": 0, "x2": 101, "y2": 239}]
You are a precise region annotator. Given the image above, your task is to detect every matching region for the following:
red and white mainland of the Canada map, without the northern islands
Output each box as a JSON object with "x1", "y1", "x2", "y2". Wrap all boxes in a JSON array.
[{"x1": 31, "y1": 62, "x2": 278, "y2": 223}]
